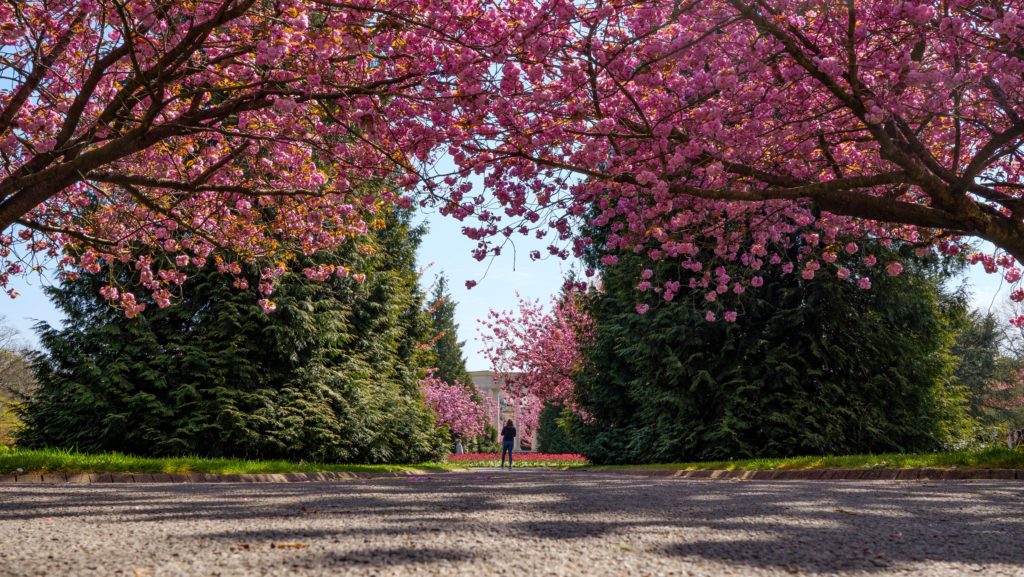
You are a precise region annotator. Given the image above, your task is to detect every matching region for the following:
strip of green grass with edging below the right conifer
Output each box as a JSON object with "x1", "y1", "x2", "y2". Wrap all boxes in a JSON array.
[{"x1": 593, "y1": 446, "x2": 1024, "y2": 470}]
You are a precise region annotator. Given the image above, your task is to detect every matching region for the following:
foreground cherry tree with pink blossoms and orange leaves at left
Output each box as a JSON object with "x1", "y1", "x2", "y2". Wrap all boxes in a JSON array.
[{"x1": 0, "y1": 0, "x2": 509, "y2": 315}]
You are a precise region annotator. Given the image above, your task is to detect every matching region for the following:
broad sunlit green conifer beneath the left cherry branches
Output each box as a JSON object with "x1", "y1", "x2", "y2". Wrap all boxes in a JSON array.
[{"x1": 18, "y1": 210, "x2": 443, "y2": 463}]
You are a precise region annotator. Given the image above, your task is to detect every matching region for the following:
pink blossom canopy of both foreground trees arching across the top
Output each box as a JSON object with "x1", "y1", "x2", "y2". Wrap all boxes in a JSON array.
[{"x1": 6, "y1": 0, "x2": 1024, "y2": 313}]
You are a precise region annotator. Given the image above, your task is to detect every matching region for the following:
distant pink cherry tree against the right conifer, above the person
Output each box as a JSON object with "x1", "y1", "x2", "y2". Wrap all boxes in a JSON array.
[{"x1": 480, "y1": 290, "x2": 593, "y2": 436}]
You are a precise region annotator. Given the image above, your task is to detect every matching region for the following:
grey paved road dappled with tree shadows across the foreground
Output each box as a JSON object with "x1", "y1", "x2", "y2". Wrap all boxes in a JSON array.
[{"x1": 0, "y1": 470, "x2": 1024, "y2": 577}]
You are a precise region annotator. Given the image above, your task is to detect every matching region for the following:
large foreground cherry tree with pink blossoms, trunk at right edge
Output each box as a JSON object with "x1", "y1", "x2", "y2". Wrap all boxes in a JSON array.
[{"x1": 438, "y1": 0, "x2": 1024, "y2": 315}]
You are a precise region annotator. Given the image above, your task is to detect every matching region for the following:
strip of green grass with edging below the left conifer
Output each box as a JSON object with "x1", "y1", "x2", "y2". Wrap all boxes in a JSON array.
[{"x1": 0, "y1": 447, "x2": 453, "y2": 475}]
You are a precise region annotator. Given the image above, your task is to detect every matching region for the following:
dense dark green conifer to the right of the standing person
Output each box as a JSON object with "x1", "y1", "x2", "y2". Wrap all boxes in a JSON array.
[{"x1": 577, "y1": 243, "x2": 969, "y2": 463}]
